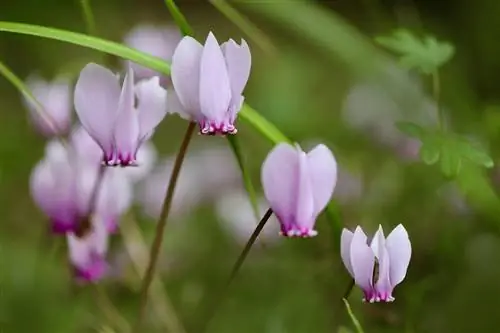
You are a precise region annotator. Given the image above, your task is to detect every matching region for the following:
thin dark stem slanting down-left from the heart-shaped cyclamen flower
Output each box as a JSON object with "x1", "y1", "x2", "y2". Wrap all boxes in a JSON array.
[{"x1": 197, "y1": 208, "x2": 273, "y2": 333}]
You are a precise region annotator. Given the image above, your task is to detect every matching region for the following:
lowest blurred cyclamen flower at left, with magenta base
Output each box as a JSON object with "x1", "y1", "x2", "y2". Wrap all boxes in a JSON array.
[{"x1": 66, "y1": 219, "x2": 109, "y2": 282}]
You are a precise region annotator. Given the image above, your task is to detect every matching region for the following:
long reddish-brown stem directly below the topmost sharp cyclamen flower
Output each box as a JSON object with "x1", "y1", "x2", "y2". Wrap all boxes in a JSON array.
[{"x1": 134, "y1": 122, "x2": 196, "y2": 333}]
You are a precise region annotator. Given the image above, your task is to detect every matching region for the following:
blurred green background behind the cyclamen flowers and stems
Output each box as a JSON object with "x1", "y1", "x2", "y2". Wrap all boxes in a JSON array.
[{"x1": 0, "y1": 0, "x2": 500, "y2": 333}]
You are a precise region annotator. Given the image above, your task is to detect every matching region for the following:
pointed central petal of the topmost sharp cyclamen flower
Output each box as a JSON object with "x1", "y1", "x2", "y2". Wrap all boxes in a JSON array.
[{"x1": 198, "y1": 32, "x2": 231, "y2": 124}]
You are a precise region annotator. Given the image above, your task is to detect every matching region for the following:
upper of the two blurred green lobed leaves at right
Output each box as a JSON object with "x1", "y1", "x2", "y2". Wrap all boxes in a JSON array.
[{"x1": 375, "y1": 29, "x2": 455, "y2": 74}]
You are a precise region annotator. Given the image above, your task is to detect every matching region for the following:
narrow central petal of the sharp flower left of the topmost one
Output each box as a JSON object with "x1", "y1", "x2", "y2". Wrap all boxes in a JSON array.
[{"x1": 114, "y1": 69, "x2": 140, "y2": 166}]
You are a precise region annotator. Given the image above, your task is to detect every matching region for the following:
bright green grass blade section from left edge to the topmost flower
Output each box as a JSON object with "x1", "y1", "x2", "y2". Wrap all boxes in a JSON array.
[{"x1": 0, "y1": 21, "x2": 170, "y2": 75}]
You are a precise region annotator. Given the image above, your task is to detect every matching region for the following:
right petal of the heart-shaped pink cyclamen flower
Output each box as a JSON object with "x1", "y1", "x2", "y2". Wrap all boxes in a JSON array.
[{"x1": 307, "y1": 144, "x2": 337, "y2": 216}]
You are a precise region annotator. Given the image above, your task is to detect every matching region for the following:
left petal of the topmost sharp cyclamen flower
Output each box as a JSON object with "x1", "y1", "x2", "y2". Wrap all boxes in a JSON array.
[{"x1": 170, "y1": 36, "x2": 203, "y2": 120}]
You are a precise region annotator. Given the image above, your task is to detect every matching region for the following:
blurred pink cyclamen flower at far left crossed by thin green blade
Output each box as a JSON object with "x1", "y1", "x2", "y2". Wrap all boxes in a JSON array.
[{"x1": 23, "y1": 76, "x2": 72, "y2": 136}]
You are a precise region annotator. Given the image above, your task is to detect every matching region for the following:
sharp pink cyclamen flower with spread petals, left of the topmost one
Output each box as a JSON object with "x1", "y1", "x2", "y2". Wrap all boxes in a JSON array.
[{"x1": 75, "y1": 63, "x2": 167, "y2": 166}]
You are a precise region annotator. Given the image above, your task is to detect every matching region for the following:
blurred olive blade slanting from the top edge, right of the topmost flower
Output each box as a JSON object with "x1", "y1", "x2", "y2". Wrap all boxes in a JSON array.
[{"x1": 210, "y1": 0, "x2": 278, "y2": 56}]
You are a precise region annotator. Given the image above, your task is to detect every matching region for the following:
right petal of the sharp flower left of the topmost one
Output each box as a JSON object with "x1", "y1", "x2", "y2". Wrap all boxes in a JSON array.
[{"x1": 135, "y1": 76, "x2": 167, "y2": 141}]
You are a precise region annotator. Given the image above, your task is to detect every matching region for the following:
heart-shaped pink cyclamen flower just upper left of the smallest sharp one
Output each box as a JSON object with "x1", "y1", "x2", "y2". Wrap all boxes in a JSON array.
[{"x1": 262, "y1": 143, "x2": 337, "y2": 237}]
